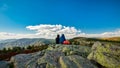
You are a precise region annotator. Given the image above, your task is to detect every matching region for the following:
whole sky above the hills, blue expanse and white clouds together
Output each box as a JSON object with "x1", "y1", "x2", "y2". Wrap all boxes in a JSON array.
[{"x1": 0, "y1": 0, "x2": 120, "y2": 39}]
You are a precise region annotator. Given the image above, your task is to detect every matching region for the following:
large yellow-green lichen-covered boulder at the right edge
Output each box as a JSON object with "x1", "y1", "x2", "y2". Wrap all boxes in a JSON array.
[{"x1": 87, "y1": 42, "x2": 120, "y2": 68}]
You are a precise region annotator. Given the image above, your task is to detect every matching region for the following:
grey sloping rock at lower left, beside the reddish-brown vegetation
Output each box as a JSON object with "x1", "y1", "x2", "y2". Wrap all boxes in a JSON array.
[{"x1": 10, "y1": 51, "x2": 44, "y2": 68}]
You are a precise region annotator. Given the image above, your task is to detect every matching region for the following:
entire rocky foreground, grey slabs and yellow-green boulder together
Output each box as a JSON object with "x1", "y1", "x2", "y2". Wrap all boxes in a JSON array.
[{"x1": 0, "y1": 42, "x2": 120, "y2": 68}]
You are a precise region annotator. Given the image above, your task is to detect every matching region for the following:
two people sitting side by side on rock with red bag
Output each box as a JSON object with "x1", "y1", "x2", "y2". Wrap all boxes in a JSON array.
[{"x1": 56, "y1": 34, "x2": 70, "y2": 45}]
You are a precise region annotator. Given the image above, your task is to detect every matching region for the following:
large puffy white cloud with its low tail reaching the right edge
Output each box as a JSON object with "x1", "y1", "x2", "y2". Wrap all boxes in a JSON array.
[{"x1": 26, "y1": 24, "x2": 120, "y2": 38}]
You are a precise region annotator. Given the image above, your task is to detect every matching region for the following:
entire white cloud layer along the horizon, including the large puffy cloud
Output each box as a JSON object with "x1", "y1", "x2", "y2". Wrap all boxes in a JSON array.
[{"x1": 0, "y1": 24, "x2": 120, "y2": 39}]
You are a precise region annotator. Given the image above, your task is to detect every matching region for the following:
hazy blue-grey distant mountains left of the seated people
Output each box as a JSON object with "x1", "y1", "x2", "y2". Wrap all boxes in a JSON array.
[{"x1": 0, "y1": 38, "x2": 54, "y2": 49}]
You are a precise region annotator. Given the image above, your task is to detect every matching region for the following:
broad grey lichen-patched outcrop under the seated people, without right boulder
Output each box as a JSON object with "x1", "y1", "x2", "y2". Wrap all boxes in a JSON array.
[{"x1": 11, "y1": 45, "x2": 97, "y2": 68}]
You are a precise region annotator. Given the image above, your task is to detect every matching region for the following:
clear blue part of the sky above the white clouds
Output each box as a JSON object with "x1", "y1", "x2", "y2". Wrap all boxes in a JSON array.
[{"x1": 0, "y1": 0, "x2": 120, "y2": 39}]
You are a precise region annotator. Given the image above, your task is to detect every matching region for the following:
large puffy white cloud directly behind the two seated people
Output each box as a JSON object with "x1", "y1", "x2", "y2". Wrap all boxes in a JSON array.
[{"x1": 26, "y1": 24, "x2": 82, "y2": 38}]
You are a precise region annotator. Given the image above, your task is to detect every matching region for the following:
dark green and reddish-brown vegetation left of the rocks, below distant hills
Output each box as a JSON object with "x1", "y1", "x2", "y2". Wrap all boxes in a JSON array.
[{"x1": 0, "y1": 45, "x2": 48, "y2": 60}]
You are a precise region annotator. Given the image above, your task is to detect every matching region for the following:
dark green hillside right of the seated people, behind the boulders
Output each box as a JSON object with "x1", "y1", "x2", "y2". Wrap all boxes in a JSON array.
[{"x1": 69, "y1": 37, "x2": 120, "y2": 46}]
